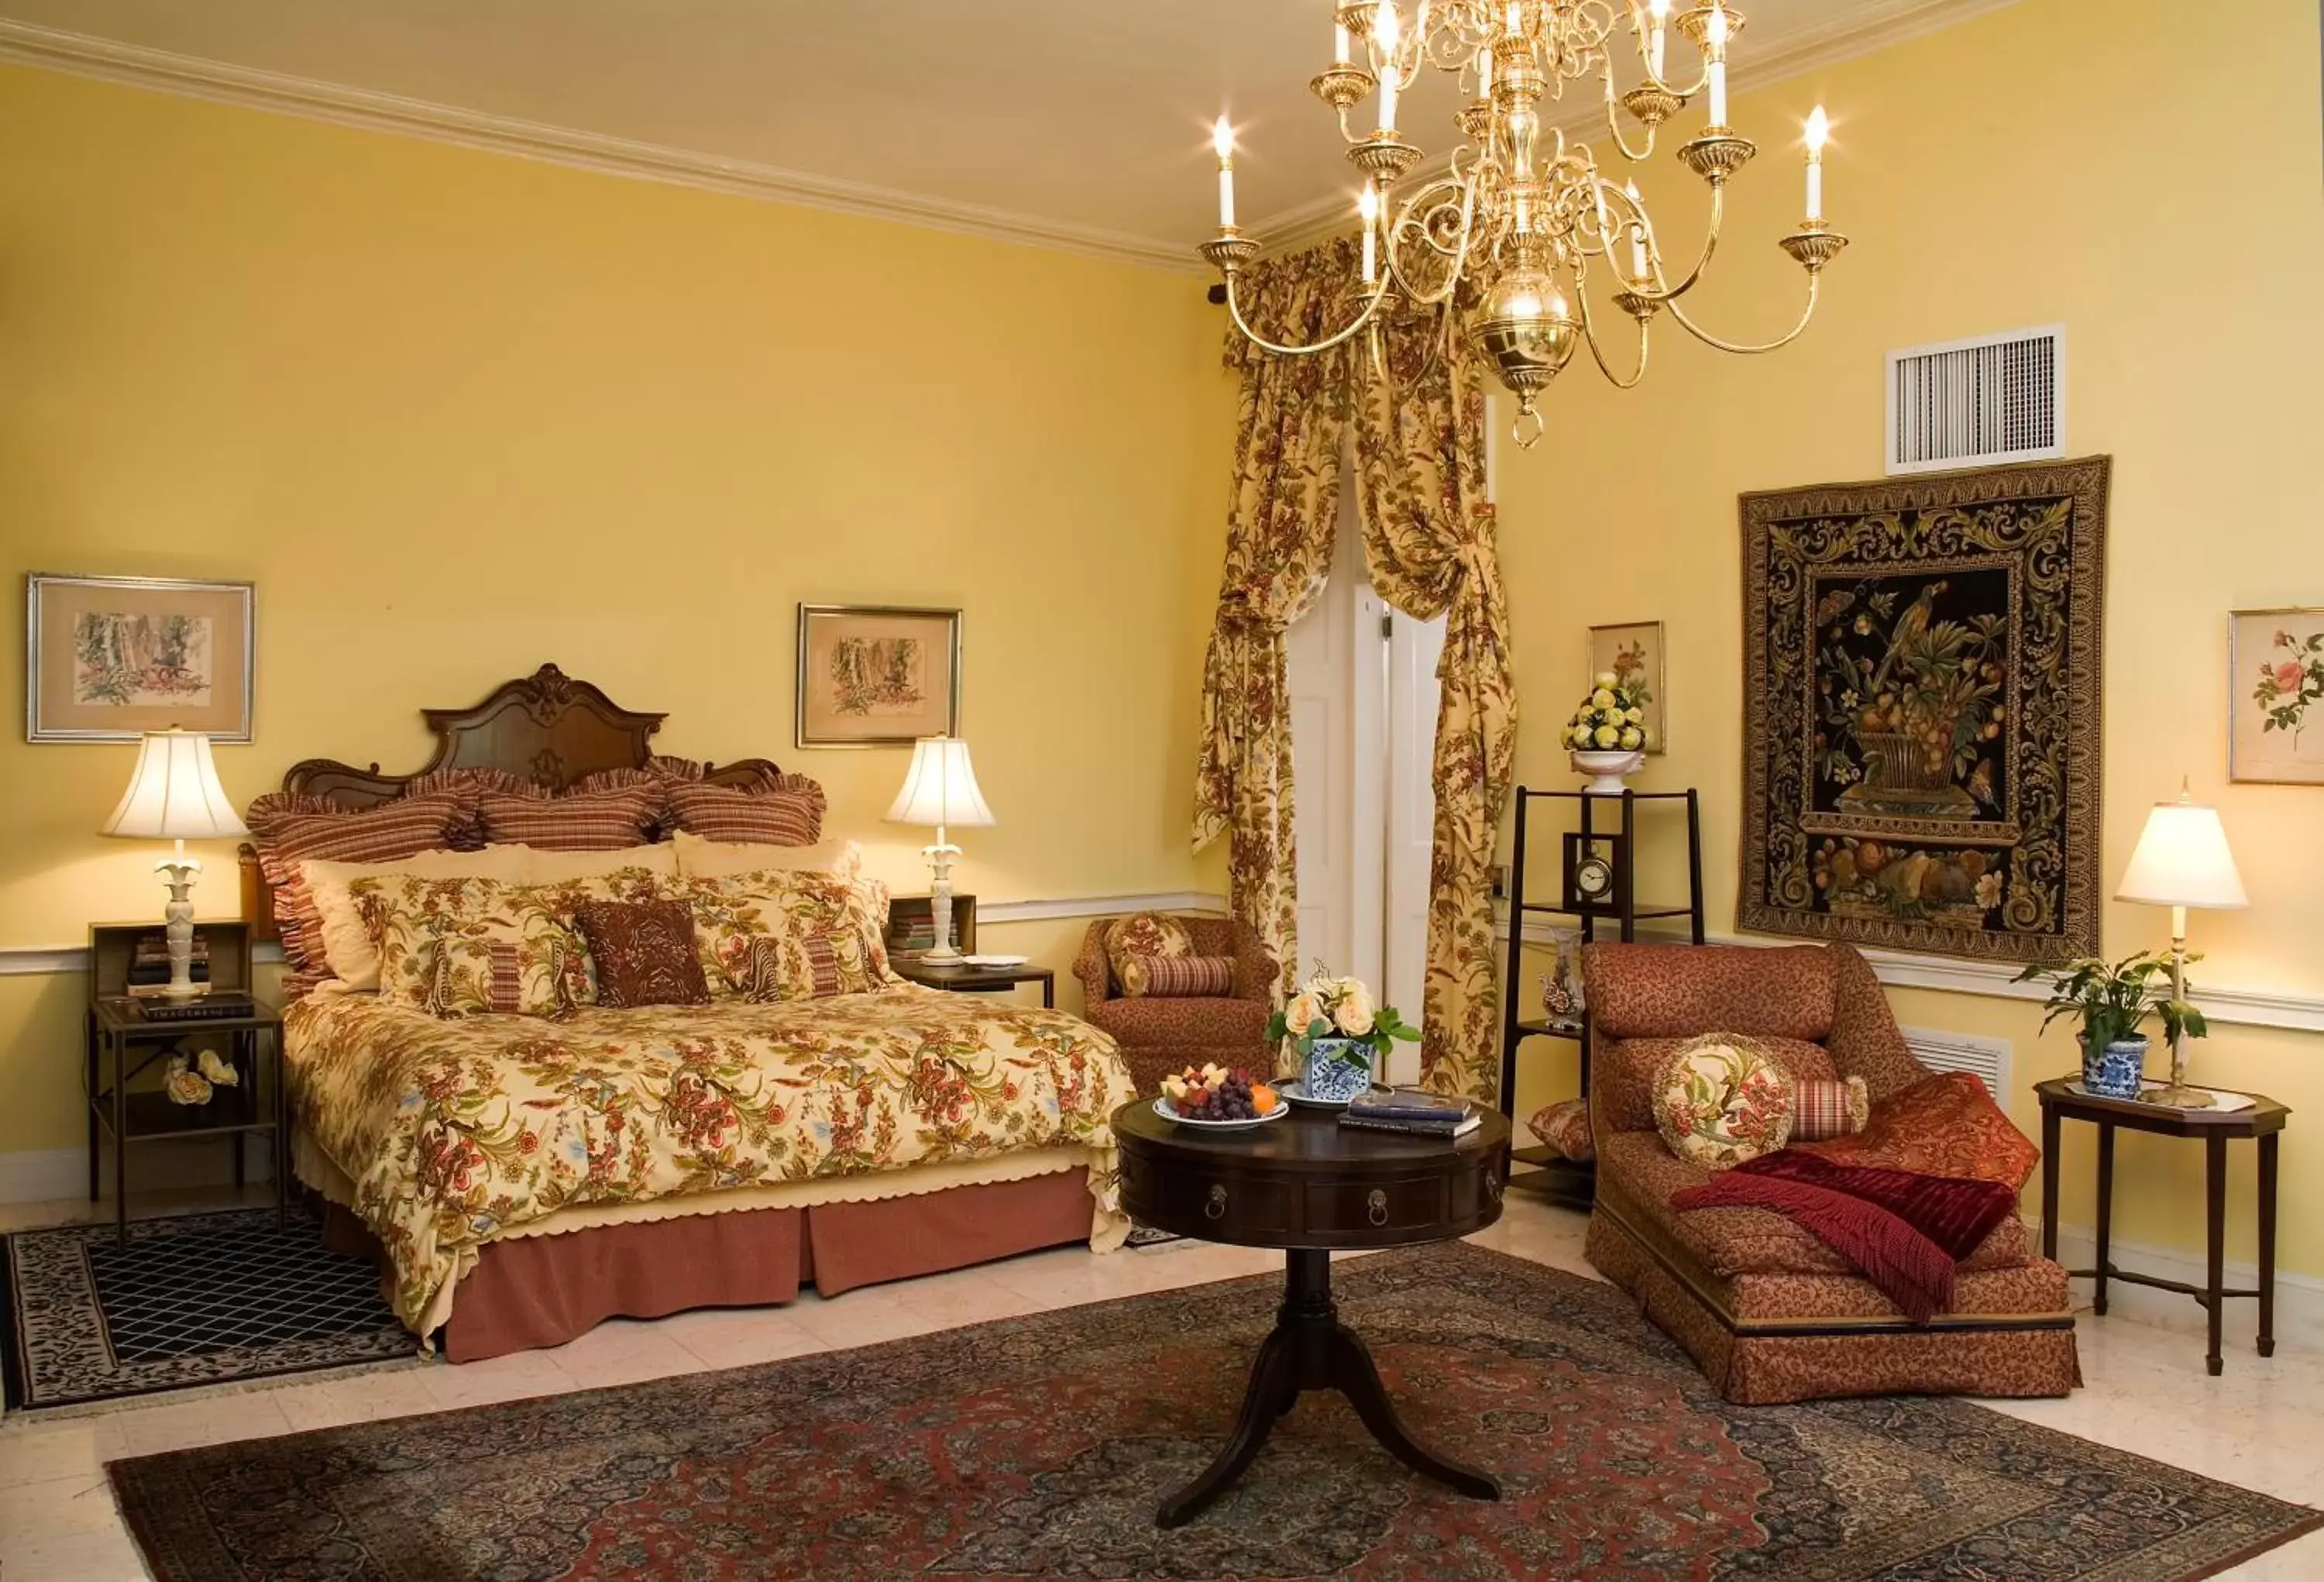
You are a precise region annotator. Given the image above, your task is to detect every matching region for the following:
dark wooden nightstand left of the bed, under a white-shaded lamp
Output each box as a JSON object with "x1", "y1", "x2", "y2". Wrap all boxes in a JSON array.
[{"x1": 81, "y1": 922, "x2": 290, "y2": 1243}]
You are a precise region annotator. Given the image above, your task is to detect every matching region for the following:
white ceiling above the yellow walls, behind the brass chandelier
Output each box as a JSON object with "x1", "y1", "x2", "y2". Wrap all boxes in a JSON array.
[{"x1": 0, "y1": 0, "x2": 1996, "y2": 256}]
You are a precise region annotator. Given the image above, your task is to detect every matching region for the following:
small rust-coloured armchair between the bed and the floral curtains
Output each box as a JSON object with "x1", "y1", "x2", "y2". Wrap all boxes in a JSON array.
[{"x1": 1074, "y1": 917, "x2": 1276, "y2": 1094}]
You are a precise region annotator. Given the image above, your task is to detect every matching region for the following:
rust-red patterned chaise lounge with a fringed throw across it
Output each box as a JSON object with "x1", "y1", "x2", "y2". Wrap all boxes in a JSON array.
[{"x1": 1583, "y1": 945, "x2": 2080, "y2": 1405}]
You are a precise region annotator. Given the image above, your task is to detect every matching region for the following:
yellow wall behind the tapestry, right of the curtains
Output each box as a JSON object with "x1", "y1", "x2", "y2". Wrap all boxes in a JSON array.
[{"x1": 1499, "y1": 0, "x2": 2324, "y2": 1273}]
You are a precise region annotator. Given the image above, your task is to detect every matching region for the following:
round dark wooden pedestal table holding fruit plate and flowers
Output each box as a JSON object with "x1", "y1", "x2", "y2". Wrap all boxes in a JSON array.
[{"x1": 1113, "y1": 1099, "x2": 1508, "y2": 1526}]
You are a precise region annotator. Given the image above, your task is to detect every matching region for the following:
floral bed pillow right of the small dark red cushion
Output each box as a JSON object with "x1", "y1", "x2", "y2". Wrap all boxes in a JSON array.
[{"x1": 676, "y1": 868, "x2": 897, "y2": 1001}]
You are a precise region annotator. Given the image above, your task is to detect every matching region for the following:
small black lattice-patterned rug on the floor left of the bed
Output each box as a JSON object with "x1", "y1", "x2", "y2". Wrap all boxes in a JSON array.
[{"x1": 0, "y1": 1208, "x2": 418, "y2": 1410}]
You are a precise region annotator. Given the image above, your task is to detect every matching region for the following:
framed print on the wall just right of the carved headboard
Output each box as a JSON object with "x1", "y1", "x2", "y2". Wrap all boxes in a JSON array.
[{"x1": 797, "y1": 604, "x2": 960, "y2": 748}]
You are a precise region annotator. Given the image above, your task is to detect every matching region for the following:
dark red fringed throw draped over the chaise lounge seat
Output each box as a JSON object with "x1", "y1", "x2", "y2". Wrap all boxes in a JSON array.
[{"x1": 1671, "y1": 1147, "x2": 2017, "y2": 1324}]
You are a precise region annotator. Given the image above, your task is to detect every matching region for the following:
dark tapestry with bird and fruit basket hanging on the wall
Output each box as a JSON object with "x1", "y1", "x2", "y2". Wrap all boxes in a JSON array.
[{"x1": 1736, "y1": 458, "x2": 2108, "y2": 961}]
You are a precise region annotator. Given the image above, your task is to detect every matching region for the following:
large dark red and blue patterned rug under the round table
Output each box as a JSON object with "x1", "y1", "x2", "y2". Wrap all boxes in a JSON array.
[{"x1": 109, "y1": 1245, "x2": 2324, "y2": 1582}]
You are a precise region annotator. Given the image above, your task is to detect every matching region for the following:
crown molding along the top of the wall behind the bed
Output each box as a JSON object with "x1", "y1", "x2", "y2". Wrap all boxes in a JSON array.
[{"x1": 0, "y1": 16, "x2": 1208, "y2": 274}]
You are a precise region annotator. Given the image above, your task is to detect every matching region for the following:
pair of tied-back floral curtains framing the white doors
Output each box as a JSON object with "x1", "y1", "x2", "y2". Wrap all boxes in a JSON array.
[{"x1": 1195, "y1": 242, "x2": 1518, "y2": 1099}]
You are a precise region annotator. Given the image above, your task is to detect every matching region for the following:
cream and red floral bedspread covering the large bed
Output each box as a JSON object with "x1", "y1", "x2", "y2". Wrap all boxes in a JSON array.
[{"x1": 284, "y1": 985, "x2": 1134, "y2": 1329}]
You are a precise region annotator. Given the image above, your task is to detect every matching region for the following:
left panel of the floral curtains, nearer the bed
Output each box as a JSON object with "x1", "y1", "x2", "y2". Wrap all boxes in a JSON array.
[{"x1": 1195, "y1": 244, "x2": 1355, "y2": 989}]
